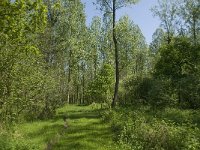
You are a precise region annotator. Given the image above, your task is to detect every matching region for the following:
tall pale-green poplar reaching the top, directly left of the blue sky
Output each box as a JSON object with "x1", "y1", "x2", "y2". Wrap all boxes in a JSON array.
[{"x1": 54, "y1": 0, "x2": 86, "y2": 103}]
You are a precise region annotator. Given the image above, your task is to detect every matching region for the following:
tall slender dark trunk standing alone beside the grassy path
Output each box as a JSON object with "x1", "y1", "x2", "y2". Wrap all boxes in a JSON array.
[{"x1": 111, "y1": 0, "x2": 119, "y2": 108}]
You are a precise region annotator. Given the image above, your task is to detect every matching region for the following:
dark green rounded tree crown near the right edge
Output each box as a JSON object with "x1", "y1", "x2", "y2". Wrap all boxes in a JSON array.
[{"x1": 155, "y1": 38, "x2": 199, "y2": 80}]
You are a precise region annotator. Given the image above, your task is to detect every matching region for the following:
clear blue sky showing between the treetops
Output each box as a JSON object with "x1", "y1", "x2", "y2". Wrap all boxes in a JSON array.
[{"x1": 81, "y1": 0, "x2": 160, "y2": 44}]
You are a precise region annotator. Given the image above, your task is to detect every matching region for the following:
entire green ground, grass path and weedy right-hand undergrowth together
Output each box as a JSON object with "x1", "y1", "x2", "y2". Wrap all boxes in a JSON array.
[{"x1": 4, "y1": 105, "x2": 200, "y2": 150}]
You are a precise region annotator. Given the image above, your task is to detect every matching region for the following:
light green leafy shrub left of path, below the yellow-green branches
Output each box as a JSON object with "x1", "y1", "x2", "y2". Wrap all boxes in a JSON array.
[{"x1": 0, "y1": 48, "x2": 59, "y2": 122}]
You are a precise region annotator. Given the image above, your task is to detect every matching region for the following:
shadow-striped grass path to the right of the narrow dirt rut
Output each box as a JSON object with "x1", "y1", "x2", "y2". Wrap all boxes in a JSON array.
[{"x1": 53, "y1": 107, "x2": 112, "y2": 150}]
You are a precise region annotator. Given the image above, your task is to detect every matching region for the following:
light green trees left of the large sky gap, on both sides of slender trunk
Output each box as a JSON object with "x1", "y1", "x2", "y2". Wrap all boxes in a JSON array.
[{"x1": 0, "y1": 0, "x2": 148, "y2": 123}]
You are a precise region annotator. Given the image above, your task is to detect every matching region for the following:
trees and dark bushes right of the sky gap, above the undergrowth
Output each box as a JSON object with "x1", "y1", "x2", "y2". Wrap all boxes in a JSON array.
[{"x1": 124, "y1": 0, "x2": 200, "y2": 109}]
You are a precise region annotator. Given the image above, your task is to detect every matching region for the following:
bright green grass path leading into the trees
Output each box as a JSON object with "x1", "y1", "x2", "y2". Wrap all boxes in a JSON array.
[{"x1": 17, "y1": 105, "x2": 117, "y2": 150}]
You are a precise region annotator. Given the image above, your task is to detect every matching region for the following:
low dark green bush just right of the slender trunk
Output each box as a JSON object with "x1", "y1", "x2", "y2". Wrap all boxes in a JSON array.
[{"x1": 121, "y1": 77, "x2": 176, "y2": 108}]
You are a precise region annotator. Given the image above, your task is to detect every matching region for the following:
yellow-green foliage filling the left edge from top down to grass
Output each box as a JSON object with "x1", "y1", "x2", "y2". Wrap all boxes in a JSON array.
[{"x1": 0, "y1": 0, "x2": 59, "y2": 124}]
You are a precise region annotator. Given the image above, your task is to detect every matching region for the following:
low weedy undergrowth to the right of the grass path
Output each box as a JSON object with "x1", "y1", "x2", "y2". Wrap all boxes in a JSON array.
[{"x1": 105, "y1": 107, "x2": 200, "y2": 150}]
